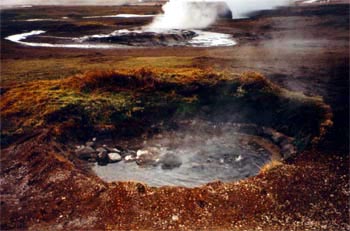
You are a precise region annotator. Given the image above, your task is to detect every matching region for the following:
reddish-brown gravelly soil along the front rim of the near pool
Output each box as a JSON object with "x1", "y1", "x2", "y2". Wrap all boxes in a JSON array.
[{"x1": 1, "y1": 132, "x2": 349, "y2": 230}]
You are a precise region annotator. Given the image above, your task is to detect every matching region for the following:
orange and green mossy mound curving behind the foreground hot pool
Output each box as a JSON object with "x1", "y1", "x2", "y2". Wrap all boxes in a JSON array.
[{"x1": 1, "y1": 68, "x2": 332, "y2": 149}]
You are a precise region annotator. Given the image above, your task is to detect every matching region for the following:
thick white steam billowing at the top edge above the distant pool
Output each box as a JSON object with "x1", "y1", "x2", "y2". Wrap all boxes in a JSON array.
[{"x1": 149, "y1": 0, "x2": 293, "y2": 30}]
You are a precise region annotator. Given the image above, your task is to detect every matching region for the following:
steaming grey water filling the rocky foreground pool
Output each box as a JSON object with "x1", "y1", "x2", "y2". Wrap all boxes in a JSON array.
[{"x1": 93, "y1": 120, "x2": 271, "y2": 187}]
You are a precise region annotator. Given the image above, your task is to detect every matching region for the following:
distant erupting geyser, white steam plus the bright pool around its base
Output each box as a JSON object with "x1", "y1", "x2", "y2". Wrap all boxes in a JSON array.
[{"x1": 6, "y1": 0, "x2": 290, "y2": 49}]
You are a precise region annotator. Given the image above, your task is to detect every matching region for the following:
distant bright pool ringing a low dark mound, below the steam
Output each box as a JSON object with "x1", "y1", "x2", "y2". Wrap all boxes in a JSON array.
[{"x1": 5, "y1": 29, "x2": 237, "y2": 49}]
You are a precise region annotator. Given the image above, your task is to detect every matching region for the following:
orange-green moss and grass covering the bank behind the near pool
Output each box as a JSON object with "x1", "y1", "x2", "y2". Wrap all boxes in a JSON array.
[{"x1": 0, "y1": 68, "x2": 332, "y2": 149}]
